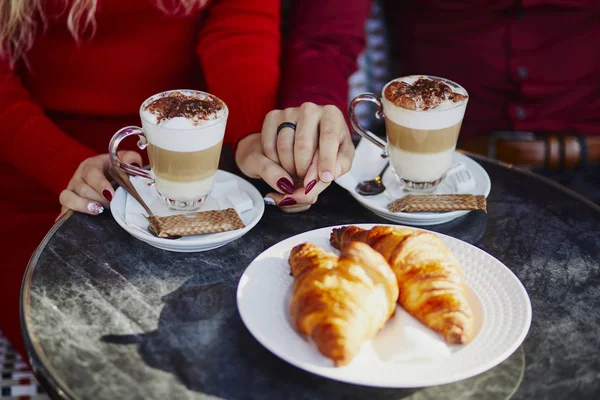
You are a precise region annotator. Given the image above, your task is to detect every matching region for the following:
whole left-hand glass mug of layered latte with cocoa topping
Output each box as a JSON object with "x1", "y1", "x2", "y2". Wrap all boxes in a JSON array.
[{"x1": 108, "y1": 90, "x2": 228, "y2": 211}]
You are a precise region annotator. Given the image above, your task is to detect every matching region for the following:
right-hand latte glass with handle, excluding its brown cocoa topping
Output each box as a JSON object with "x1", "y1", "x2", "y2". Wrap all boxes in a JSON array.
[{"x1": 349, "y1": 75, "x2": 468, "y2": 192}]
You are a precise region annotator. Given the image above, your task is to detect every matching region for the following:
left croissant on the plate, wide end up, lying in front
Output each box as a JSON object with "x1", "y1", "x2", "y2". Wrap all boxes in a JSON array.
[{"x1": 289, "y1": 242, "x2": 398, "y2": 366}]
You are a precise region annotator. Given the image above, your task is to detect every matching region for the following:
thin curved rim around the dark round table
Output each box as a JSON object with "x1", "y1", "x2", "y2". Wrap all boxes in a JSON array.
[{"x1": 19, "y1": 155, "x2": 600, "y2": 400}]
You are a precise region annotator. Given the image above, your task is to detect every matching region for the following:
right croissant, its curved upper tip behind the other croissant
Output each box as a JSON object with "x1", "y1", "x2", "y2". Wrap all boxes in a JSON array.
[{"x1": 330, "y1": 226, "x2": 473, "y2": 344}]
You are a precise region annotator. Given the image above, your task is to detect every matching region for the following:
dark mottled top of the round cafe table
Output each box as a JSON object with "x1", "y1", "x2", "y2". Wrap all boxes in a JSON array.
[{"x1": 21, "y1": 152, "x2": 600, "y2": 400}]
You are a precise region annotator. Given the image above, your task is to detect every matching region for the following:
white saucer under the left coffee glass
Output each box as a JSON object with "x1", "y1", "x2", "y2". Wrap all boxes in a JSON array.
[{"x1": 110, "y1": 170, "x2": 265, "y2": 253}]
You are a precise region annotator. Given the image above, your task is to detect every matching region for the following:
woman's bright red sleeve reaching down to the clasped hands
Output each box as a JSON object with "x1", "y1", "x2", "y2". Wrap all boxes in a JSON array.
[{"x1": 197, "y1": 0, "x2": 281, "y2": 145}]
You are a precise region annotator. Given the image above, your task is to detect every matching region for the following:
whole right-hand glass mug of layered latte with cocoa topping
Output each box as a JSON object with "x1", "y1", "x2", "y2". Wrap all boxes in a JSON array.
[{"x1": 349, "y1": 75, "x2": 469, "y2": 192}]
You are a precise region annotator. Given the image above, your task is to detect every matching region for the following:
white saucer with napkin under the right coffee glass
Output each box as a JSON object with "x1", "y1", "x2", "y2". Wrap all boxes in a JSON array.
[{"x1": 336, "y1": 140, "x2": 492, "y2": 226}]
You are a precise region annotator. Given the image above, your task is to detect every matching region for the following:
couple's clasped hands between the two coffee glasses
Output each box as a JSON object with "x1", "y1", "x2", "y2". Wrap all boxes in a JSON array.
[{"x1": 236, "y1": 103, "x2": 354, "y2": 212}]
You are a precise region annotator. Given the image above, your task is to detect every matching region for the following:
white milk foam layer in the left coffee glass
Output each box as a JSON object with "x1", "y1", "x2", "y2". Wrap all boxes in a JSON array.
[{"x1": 140, "y1": 90, "x2": 228, "y2": 152}]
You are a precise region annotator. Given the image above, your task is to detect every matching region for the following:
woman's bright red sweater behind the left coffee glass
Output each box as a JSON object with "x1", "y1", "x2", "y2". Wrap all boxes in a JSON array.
[{"x1": 0, "y1": 0, "x2": 280, "y2": 197}]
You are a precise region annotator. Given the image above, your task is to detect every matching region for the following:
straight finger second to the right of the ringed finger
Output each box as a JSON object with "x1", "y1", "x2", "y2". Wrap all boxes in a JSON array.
[{"x1": 318, "y1": 106, "x2": 345, "y2": 183}]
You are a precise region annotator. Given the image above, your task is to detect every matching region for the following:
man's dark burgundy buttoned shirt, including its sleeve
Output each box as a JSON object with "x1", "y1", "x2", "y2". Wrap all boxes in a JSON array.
[{"x1": 283, "y1": 0, "x2": 600, "y2": 138}]
